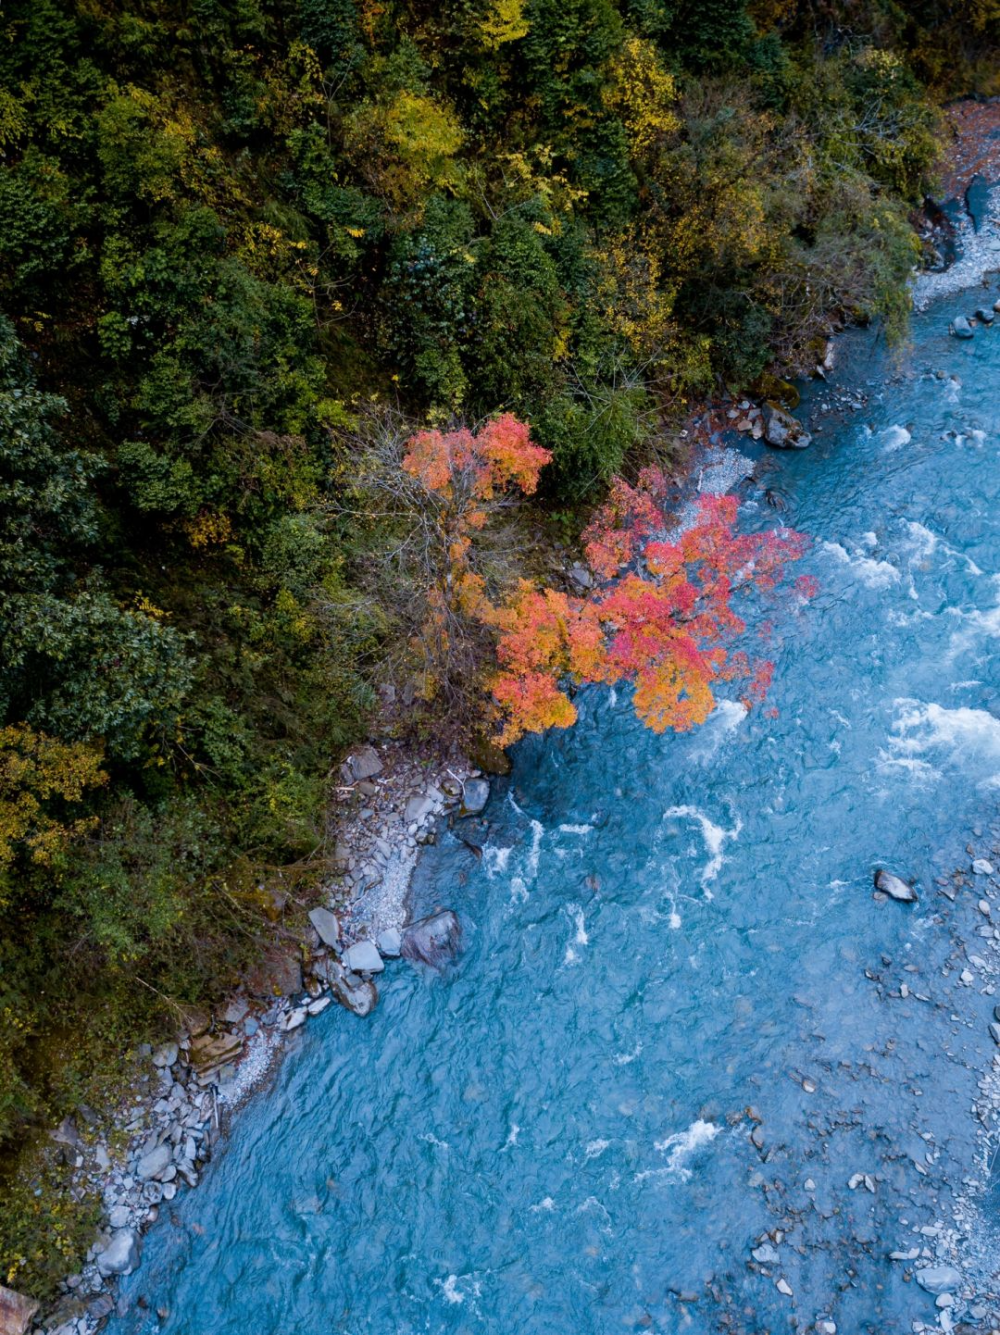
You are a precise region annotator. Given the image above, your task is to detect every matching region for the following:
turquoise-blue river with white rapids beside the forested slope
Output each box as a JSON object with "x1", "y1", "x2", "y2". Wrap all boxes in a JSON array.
[{"x1": 103, "y1": 276, "x2": 1000, "y2": 1335}]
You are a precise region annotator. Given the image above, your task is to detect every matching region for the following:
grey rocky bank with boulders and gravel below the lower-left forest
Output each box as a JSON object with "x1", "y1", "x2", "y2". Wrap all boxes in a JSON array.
[{"x1": 0, "y1": 745, "x2": 490, "y2": 1335}]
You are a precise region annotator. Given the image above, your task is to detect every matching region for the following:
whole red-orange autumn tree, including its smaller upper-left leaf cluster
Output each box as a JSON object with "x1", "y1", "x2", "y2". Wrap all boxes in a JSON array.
[{"x1": 355, "y1": 414, "x2": 813, "y2": 746}]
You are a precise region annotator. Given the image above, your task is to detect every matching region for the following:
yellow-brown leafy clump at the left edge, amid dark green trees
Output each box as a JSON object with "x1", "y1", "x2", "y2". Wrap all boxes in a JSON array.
[{"x1": 0, "y1": 724, "x2": 108, "y2": 869}]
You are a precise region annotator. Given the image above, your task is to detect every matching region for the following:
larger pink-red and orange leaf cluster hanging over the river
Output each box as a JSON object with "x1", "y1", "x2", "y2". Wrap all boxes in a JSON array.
[{"x1": 490, "y1": 470, "x2": 814, "y2": 746}]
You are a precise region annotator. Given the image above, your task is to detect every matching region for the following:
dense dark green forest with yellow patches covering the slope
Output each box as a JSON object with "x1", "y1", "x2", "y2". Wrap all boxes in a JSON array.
[{"x1": 0, "y1": 0, "x2": 1000, "y2": 1292}]
